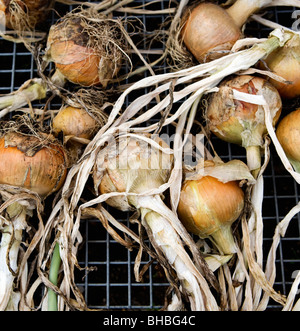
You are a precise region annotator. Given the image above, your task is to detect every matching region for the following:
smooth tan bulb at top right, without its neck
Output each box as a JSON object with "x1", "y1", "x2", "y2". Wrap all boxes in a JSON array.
[{"x1": 182, "y1": 3, "x2": 242, "y2": 62}]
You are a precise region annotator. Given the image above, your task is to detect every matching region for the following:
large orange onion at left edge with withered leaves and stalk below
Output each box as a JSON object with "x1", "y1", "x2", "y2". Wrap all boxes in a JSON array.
[{"x1": 0, "y1": 121, "x2": 67, "y2": 310}]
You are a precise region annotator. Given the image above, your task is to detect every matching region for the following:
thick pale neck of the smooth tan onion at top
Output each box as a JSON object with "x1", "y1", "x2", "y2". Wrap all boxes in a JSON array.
[{"x1": 226, "y1": 0, "x2": 272, "y2": 28}]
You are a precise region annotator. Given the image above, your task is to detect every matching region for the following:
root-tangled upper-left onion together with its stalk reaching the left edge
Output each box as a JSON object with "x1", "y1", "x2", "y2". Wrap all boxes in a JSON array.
[{"x1": 0, "y1": 9, "x2": 126, "y2": 117}]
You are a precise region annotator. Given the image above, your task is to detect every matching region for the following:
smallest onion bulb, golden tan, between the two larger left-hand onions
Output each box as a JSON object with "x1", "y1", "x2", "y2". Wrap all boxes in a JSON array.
[{"x1": 52, "y1": 106, "x2": 98, "y2": 139}]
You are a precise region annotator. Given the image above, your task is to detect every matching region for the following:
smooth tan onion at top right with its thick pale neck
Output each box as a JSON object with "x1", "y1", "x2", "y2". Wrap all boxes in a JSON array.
[{"x1": 182, "y1": 0, "x2": 299, "y2": 62}]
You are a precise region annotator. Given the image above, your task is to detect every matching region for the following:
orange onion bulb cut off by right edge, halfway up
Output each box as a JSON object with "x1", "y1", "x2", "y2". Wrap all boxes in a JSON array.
[{"x1": 276, "y1": 108, "x2": 300, "y2": 173}]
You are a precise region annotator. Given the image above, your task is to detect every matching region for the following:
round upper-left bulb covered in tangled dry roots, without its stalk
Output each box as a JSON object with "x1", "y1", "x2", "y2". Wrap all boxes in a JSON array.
[{"x1": 45, "y1": 10, "x2": 124, "y2": 87}]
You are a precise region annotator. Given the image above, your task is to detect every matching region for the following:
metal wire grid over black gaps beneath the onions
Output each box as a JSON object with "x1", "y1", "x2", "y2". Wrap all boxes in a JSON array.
[{"x1": 0, "y1": 0, "x2": 300, "y2": 310}]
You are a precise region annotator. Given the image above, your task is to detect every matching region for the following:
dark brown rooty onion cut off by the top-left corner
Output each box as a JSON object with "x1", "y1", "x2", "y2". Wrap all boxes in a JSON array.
[{"x1": 0, "y1": 0, "x2": 54, "y2": 29}]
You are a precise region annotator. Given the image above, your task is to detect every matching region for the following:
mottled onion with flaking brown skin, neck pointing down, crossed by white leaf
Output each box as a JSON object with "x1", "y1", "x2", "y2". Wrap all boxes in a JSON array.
[{"x1": 206, "y1": 75, "x2": 282, "y2": 177}]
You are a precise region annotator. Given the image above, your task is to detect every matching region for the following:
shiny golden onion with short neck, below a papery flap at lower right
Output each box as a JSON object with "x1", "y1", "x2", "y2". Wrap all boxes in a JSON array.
[{"x1": 178, "y1": 161, "x2": 244, "y2": 255}]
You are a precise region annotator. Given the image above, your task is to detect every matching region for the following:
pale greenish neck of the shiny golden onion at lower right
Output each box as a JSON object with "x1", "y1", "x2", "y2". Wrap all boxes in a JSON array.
[{"x1": 209, "y1": 225, "x2": 237, "y2": 255}]
